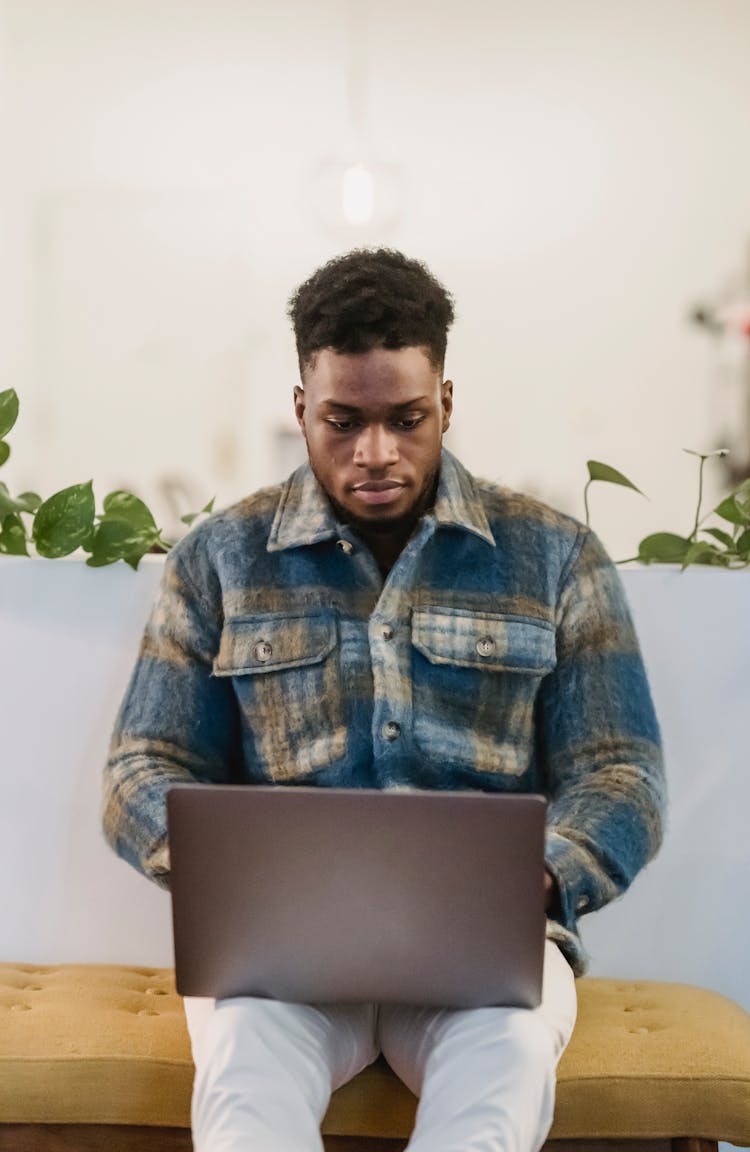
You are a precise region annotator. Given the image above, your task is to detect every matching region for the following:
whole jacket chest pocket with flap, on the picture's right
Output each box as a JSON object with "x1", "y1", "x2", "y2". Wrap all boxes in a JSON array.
[{"x1": 411, "y1": 606, "x2": 556, "y2": 776}]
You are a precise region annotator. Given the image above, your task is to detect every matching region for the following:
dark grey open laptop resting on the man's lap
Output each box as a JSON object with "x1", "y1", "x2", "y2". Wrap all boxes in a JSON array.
[{"x1": 167, "y1": 785, "x2": 546, "y2": 1008}]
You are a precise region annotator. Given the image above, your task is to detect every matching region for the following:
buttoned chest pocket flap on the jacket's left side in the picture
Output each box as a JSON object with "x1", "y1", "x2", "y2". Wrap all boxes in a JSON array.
[{"x1": 213, "y1": 612, "x2": 336, "y2": 676}]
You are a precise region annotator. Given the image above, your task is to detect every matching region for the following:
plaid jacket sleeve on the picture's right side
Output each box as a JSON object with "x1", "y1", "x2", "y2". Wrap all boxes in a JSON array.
[{"x1": 537, "y1": 528, "x2": 666, "y2": 949}]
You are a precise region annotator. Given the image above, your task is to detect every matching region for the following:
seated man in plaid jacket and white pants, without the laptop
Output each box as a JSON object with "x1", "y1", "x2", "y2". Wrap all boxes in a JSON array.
[{"x1": 105, "y1": 250, "x2": 664, "y2": 1152}]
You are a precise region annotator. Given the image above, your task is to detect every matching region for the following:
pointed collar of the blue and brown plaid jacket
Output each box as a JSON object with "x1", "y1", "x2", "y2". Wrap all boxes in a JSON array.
[{"x1": 266, "y1": 448, "x2": 495, "y2": 552}]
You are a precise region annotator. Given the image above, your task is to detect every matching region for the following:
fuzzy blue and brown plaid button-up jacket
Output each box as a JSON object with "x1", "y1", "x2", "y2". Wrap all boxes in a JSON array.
[{"x1": 104, "y1": 452, "x2": 665, "y2": 972}]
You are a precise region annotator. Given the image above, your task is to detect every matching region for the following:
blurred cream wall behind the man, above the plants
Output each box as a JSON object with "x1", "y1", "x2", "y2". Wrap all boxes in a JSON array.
[{"x1": 0, "y1": 0, "x2": 750, "y2": 559}]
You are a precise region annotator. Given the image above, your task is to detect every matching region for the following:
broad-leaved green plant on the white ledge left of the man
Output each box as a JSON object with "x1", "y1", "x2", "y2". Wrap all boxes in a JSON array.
[{"x1": 0, "y1": 388, "x2": 213, "y2": 569}]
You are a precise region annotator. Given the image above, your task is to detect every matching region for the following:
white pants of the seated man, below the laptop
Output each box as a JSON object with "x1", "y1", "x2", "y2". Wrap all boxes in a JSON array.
[{"x1": 184, "y1": 941, "x2": 576, "y2": 1152}]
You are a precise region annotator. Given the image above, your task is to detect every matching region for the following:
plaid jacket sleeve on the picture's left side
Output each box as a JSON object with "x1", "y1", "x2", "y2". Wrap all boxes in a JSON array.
[{"x1": 104, "y1": 537, "x2": 238, "y2": 887}]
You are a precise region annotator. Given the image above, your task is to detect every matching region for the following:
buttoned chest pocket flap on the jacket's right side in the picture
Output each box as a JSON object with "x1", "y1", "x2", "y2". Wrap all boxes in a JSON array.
[{"x1": 411, "y1": 607, "x2": 556, "y2": 674}]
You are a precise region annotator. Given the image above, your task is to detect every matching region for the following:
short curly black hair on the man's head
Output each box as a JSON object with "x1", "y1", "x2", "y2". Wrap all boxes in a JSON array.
[{"x1": 288, "y1": 248, "x2": 454, "y2": 372}]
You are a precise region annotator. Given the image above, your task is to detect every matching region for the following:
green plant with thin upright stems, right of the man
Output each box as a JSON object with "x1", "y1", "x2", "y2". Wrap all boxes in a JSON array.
[{"x1": 583, "y1": 448, "x2": 750, "y2": 570}]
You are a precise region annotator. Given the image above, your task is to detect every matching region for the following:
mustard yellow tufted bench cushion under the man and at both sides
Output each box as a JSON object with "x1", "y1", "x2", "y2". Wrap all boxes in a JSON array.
[{"x1": 0, "y1": 964, "x2": 750, "y2": 1147}]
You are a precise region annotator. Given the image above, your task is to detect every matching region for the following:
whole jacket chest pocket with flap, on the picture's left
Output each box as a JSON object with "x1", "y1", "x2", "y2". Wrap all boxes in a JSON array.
[{"x1": 213, "y1": 609, "x2": 346, "y2": 782}]
